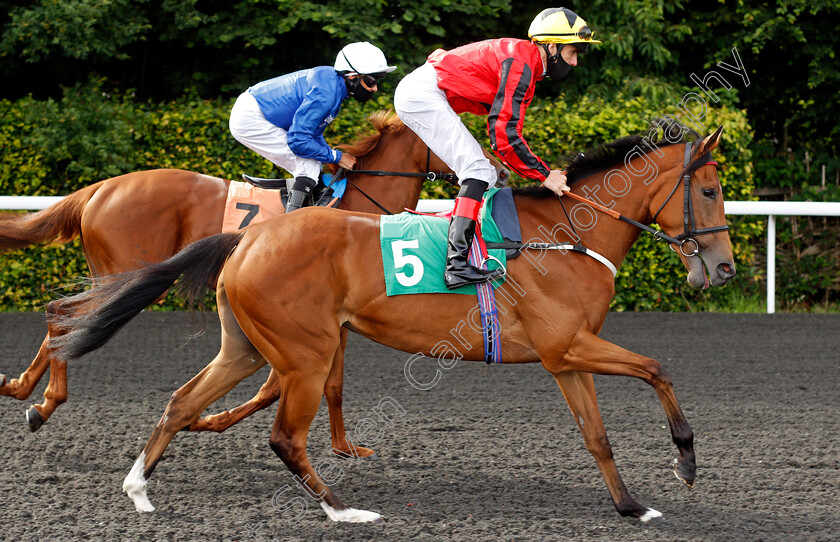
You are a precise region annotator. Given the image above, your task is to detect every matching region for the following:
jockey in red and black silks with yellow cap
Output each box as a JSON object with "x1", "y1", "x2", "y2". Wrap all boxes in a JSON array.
[{"x1": 394, "y1": 8, "x2": 600, "y2": 289}]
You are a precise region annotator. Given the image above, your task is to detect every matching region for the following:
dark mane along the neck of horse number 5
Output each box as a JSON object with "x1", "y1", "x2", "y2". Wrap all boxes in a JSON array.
[{"x1": 513, "y1": 119, "x2": 702, "y2": 198}]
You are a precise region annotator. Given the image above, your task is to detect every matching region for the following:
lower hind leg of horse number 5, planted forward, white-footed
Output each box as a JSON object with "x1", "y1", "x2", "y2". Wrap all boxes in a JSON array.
[{"x1": 270, "y1": 371, "x2": 381, "y2": 523}]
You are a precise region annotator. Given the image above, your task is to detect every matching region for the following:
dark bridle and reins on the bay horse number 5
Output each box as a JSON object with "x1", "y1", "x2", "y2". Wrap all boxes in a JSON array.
[{"x1": 560, "y1": 141, "x2": 729, "y2": 258}]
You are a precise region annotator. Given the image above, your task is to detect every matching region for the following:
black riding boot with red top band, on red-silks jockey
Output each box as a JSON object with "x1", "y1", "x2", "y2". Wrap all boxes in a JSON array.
[{"x1": 443, "y1": 179, "x2": 504, "y2": 290}]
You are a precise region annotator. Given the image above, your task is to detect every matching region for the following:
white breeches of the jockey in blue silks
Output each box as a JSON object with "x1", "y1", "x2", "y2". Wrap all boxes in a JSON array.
[{"x1": 230, "y1": 92, "x2": 321, "y2": 181}]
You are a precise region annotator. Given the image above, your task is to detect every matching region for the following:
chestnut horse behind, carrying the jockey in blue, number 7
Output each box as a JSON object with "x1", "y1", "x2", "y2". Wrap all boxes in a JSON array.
[{"x1": 0, "y1": 111, "x2": 508, "y2": 456}]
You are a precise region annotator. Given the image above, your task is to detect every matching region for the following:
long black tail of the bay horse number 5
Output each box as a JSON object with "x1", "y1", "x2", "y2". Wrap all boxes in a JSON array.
[{"x1": 49, "y1": 232, "x2": 245, "y2": 361}]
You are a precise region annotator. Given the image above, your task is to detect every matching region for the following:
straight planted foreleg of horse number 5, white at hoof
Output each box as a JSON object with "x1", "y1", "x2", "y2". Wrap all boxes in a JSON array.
[{"x1": 552, "y1": 371, "x2": 662, "y2": 523}]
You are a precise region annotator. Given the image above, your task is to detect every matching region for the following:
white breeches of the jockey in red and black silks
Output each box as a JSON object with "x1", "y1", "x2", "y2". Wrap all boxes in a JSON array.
[{"x1": 394, "y1": 63, "x2": 497, "y2": 187}]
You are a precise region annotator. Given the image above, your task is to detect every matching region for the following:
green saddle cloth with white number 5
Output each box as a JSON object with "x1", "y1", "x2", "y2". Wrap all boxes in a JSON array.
[{"x1": 379, "y1": 188, "x2": 506, "y2": 296}]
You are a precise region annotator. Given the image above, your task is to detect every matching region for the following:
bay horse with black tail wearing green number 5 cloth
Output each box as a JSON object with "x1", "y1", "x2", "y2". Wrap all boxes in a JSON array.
[{"x1": 50, "y1": 128, "x2": 735, "y2": 522}]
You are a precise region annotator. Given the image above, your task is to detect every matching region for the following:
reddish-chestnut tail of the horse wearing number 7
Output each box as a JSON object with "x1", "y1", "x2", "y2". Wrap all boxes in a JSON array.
[{"x1": 0, "y1": 181, "x2": 105, "y2": 252}]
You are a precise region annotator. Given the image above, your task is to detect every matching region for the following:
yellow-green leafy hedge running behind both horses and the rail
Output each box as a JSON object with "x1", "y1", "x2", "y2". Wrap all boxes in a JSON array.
[{"x1": 0, "y1": 84, "x2": 761, "y2": 311}]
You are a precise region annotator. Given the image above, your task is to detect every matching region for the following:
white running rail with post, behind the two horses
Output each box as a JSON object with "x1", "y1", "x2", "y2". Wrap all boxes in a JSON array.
[{"x1": 0, "y1": 196, "x2": 840, "y2": 314}]
